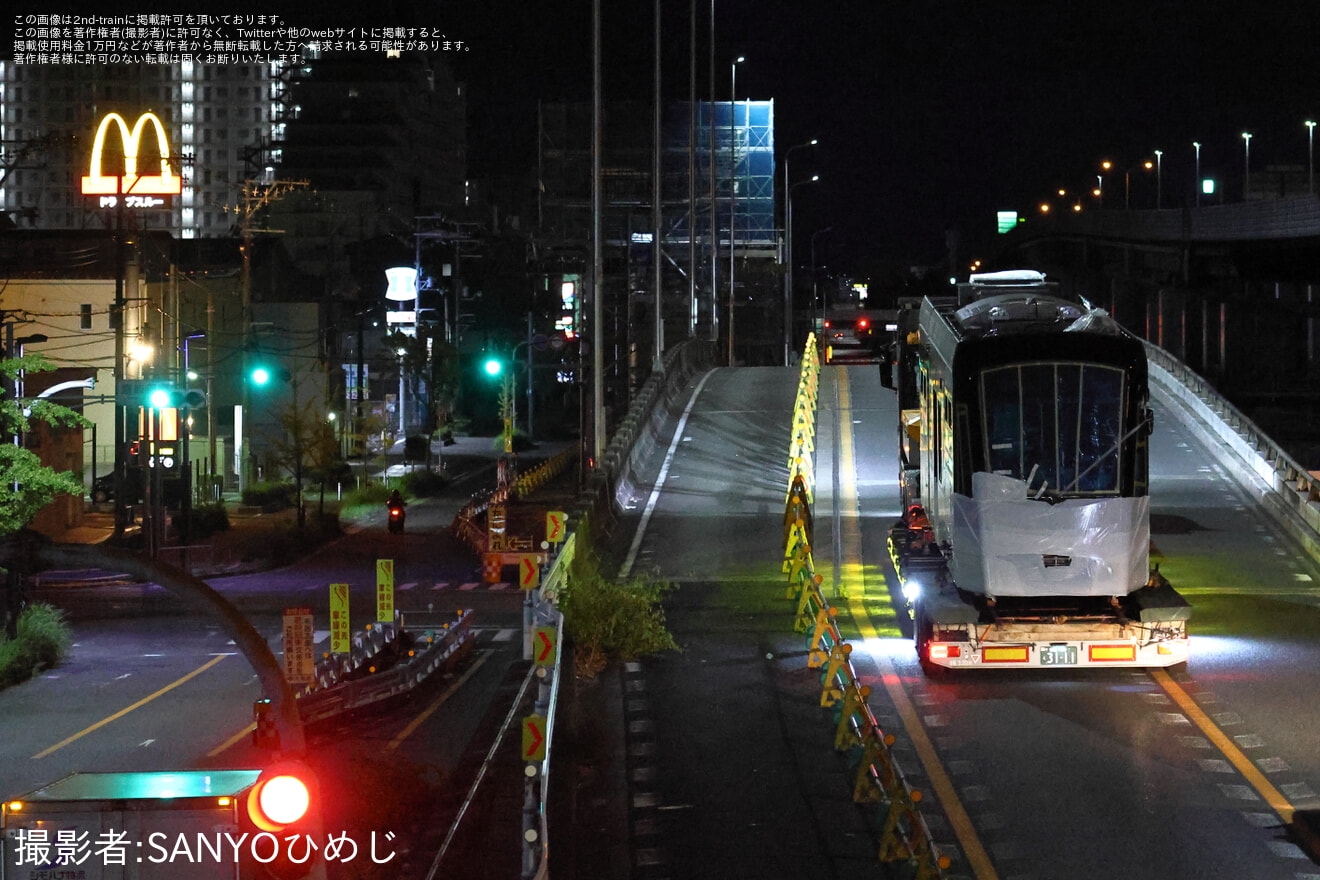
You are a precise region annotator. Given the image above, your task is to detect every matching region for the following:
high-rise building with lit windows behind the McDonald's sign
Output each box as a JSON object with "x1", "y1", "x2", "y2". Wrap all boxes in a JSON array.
[{"x1": 0, "y1": 61, "x2": 285, "y2": 239}]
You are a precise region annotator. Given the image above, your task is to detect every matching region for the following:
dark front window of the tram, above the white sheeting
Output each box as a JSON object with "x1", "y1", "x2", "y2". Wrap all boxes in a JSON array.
[{"x1": 981, "y1": 363, "x2": 1123, "y2": 495}]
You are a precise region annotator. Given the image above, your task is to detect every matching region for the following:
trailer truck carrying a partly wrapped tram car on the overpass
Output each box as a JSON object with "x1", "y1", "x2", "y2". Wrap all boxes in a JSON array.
[{"x1": 880, "y1": 269, "x2": 1191, "y2": 674}]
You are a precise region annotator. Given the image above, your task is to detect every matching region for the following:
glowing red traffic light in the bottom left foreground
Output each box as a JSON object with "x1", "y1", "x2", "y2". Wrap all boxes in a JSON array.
[{"x1": 240, "y1": 761, "x2": 323, "y2": 880}]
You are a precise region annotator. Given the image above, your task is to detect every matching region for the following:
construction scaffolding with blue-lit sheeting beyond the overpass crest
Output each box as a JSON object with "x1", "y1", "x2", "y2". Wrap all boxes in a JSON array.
[{"x1": 537, "y1": 100, "x2": 783, "y2": 393}]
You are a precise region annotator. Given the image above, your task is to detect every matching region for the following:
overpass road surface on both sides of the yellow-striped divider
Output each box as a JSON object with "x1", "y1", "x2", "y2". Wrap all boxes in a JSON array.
[{"x1": 596, "y1": 358, "x2": 1320, "y2": 880}]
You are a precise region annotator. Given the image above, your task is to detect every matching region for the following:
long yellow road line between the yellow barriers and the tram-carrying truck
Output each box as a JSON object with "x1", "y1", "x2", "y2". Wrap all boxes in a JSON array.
[{"x1": 834, "y1": 368, "x2": 999, "y2": 880}]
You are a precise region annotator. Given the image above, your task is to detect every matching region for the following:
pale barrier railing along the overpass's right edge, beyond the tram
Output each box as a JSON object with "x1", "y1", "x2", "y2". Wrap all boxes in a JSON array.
[{"x1": 1146, "y1": 342, "x2": 1320, "y2": 559}]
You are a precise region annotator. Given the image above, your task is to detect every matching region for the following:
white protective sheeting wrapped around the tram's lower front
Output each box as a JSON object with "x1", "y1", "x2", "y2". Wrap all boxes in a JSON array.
[{"x1": 949, "y1": 472, "x2": 1150, "y2": 596}]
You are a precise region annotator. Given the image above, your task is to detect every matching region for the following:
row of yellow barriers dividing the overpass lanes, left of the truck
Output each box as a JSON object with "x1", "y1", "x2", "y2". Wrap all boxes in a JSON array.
[{"x1": 783, "y1": 336, "x2": 950, "y2": 880}]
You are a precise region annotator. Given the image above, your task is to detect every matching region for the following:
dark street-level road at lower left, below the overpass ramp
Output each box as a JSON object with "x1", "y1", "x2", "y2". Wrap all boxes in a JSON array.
[{"x1": 0, "y1": 464, "x2": 541, "y2": 877}]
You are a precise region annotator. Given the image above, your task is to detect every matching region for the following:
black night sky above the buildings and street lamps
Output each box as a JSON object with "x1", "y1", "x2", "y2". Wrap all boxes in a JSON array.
[{"x1": 12, "y1": 0, "x2": 1320, "y2": 273}]
